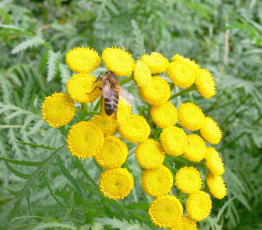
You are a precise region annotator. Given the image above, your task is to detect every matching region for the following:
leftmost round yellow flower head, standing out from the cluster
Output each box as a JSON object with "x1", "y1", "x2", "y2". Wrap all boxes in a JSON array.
[{"x1": 41, "y1": 93, "x2": 75, "y2": 128}]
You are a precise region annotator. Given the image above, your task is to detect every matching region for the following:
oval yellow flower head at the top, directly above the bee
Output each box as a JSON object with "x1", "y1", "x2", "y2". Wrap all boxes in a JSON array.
[{"x1": 102, "y1": 47, "x2": 135, "y2": 76}]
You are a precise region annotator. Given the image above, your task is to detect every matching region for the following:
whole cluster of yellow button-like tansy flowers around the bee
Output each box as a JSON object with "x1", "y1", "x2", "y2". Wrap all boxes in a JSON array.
[{"x1": 42, "y1": 47, "x2": 227, "y2": 229}]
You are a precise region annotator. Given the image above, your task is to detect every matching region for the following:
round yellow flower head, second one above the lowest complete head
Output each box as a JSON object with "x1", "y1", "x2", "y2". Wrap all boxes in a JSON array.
[{"x1": 136, "y1": 139, "x2": 165, "y2": 169}]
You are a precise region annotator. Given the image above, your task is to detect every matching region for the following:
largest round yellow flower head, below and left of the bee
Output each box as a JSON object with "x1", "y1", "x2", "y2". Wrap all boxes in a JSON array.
[{"x1": 66, "y1": 121, "x2": 104, "y2": 160}]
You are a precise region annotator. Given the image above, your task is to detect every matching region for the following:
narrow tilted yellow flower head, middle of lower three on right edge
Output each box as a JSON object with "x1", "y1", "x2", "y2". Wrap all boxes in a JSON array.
[{"x1": 206, "y1": 147, "x2": 225, "y2": 176}]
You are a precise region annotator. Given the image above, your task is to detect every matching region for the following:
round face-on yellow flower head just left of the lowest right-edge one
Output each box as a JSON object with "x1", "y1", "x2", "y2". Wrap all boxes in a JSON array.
[{"x1": 175, "y1": 166, "x2": 202, "y2": 194}]
